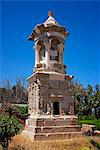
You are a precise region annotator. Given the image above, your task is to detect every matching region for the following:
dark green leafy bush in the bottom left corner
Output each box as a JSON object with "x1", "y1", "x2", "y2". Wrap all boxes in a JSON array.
[{"x1": 0, "y1": 113, "x2": 23, "y2": 148}]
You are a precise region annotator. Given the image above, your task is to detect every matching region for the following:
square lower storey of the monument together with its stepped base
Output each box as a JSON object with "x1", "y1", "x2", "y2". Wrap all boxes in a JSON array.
[{"x1": 23, "y1": 72, "x2": 81, "y2": 141}]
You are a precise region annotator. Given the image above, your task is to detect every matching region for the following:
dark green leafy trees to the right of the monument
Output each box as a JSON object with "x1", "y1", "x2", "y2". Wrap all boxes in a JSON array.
[{"x1": 73, "y1": 82, "x2": 100, "y2": 118}]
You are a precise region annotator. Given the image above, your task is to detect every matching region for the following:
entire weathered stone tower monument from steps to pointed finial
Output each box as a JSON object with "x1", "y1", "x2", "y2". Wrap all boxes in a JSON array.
[{"x1": 24, "y1": 12, "x2": 81, "y2": 140}]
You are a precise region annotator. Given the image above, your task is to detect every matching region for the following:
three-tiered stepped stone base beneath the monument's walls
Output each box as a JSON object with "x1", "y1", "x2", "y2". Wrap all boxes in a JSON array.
[{"x1": 22, "y1": 115, "x2": 82, "y2": 141}]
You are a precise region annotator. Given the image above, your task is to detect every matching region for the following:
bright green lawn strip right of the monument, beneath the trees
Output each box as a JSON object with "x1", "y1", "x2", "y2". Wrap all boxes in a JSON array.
[{"x1": 78, "y1": 119, "x2": 100, "y2": 130}]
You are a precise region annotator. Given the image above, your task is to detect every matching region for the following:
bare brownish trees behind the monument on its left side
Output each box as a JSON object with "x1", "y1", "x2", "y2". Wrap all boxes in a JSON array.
[{"x1": 0, "y1": 78, "x2": 28, "y2": 104}]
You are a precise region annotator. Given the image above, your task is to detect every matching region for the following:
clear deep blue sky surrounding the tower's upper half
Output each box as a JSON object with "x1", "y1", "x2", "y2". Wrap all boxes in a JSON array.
[{"x1": 0, "y1": 1, "x2": 100, "y2": 86}]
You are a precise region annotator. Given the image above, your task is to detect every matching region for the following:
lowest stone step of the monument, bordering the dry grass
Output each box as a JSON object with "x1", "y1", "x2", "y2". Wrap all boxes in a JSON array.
[{"x1": 34, "y1": 132, "x2": 82, "y2": 141}]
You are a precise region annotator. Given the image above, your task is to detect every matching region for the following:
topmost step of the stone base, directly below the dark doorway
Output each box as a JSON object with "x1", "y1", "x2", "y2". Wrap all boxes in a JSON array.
[{"x1": 28, "y1": 115, "x2": 77, "y2": 126}]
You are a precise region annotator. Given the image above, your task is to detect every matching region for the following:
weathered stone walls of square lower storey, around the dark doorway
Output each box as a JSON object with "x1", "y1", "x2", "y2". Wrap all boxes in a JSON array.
[{"x1": 28, "y1": 73, "x2": 74, "y2": 115}]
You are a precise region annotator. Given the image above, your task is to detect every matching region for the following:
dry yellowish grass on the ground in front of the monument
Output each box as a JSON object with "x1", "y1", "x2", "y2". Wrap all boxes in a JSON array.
[{"x1": 8, "y1": 135, "x2": 100, "y2": 150}]
